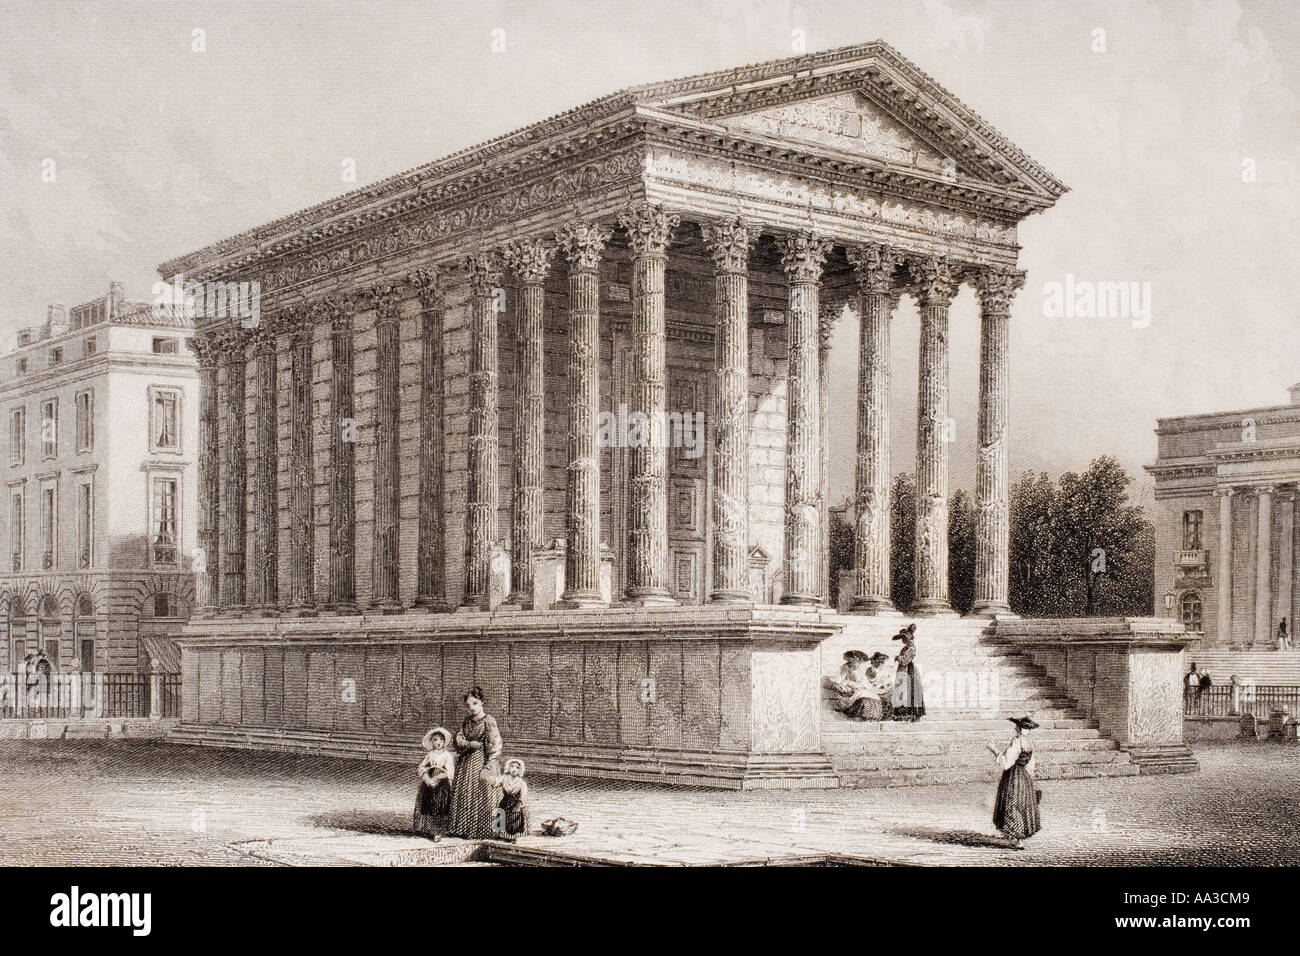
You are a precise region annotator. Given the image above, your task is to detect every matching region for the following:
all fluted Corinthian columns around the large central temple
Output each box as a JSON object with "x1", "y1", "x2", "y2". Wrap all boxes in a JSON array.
[{"x1": 196, "y1": 202, "x2": 1023, "y2": 614}]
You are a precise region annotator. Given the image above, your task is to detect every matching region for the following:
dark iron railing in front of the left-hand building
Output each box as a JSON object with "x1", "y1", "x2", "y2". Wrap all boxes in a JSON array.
[{"x1": 0, "y1": 672, "x2": 181, "y2": 718}]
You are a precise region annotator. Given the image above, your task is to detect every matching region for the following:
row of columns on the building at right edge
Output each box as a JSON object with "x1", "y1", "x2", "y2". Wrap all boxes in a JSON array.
[{"x1": 1214, "y1": 485, "x2": 1296, "y2": 645}]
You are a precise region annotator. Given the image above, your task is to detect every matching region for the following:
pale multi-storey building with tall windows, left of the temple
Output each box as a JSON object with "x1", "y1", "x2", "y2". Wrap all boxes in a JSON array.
[{"x1": 0, "y1": 282, "x2": 199, "y2": 672}]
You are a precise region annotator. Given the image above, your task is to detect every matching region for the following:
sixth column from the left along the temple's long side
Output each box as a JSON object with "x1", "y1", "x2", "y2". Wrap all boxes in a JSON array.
[{"x1": 369, "y1": 282, "x2": 402, "y2": 614}]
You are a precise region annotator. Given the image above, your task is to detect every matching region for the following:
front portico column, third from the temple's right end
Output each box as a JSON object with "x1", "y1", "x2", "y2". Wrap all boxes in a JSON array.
[{"x1": 849, "y1": 246, "x2": 901, "y2": 614}]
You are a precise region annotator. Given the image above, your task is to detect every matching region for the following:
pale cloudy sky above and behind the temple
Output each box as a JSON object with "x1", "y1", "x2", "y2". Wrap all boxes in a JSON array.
[{"x1": 0, "y1": 0, "x2": 1300, "y2": 501}]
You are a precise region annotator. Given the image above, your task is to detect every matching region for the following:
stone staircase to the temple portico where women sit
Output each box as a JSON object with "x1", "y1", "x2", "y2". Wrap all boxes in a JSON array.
[{"x1": 822, "y1": 615, "x2": 1138, "y2": 787}]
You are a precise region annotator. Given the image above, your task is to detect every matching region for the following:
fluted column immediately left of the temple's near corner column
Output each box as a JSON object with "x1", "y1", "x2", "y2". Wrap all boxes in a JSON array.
[{"x1": 555, "y1": 222, "x2": 610, "y2": 607}]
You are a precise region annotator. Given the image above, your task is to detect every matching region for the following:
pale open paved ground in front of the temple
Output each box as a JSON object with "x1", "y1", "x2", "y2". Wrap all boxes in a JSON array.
[{"x1": 0, "y1": 740, "x2": 1300, "y2": 865}]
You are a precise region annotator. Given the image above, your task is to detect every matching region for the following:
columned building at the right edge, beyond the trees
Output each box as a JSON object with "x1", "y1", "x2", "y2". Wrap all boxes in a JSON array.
[{"x1": 1147, "y1": 384, "x2": 1300, "y2": 649}]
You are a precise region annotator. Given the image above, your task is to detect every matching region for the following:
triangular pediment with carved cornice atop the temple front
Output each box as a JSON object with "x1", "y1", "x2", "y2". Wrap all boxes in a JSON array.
[{"x1": 631, "y1": 42, "x2": 1066, "y2": 204}]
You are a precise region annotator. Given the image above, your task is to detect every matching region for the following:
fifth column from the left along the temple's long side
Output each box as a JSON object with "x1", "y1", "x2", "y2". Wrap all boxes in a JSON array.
[{"x1": 325, "y1": 295, "x2": 358, "y2": 614}]
